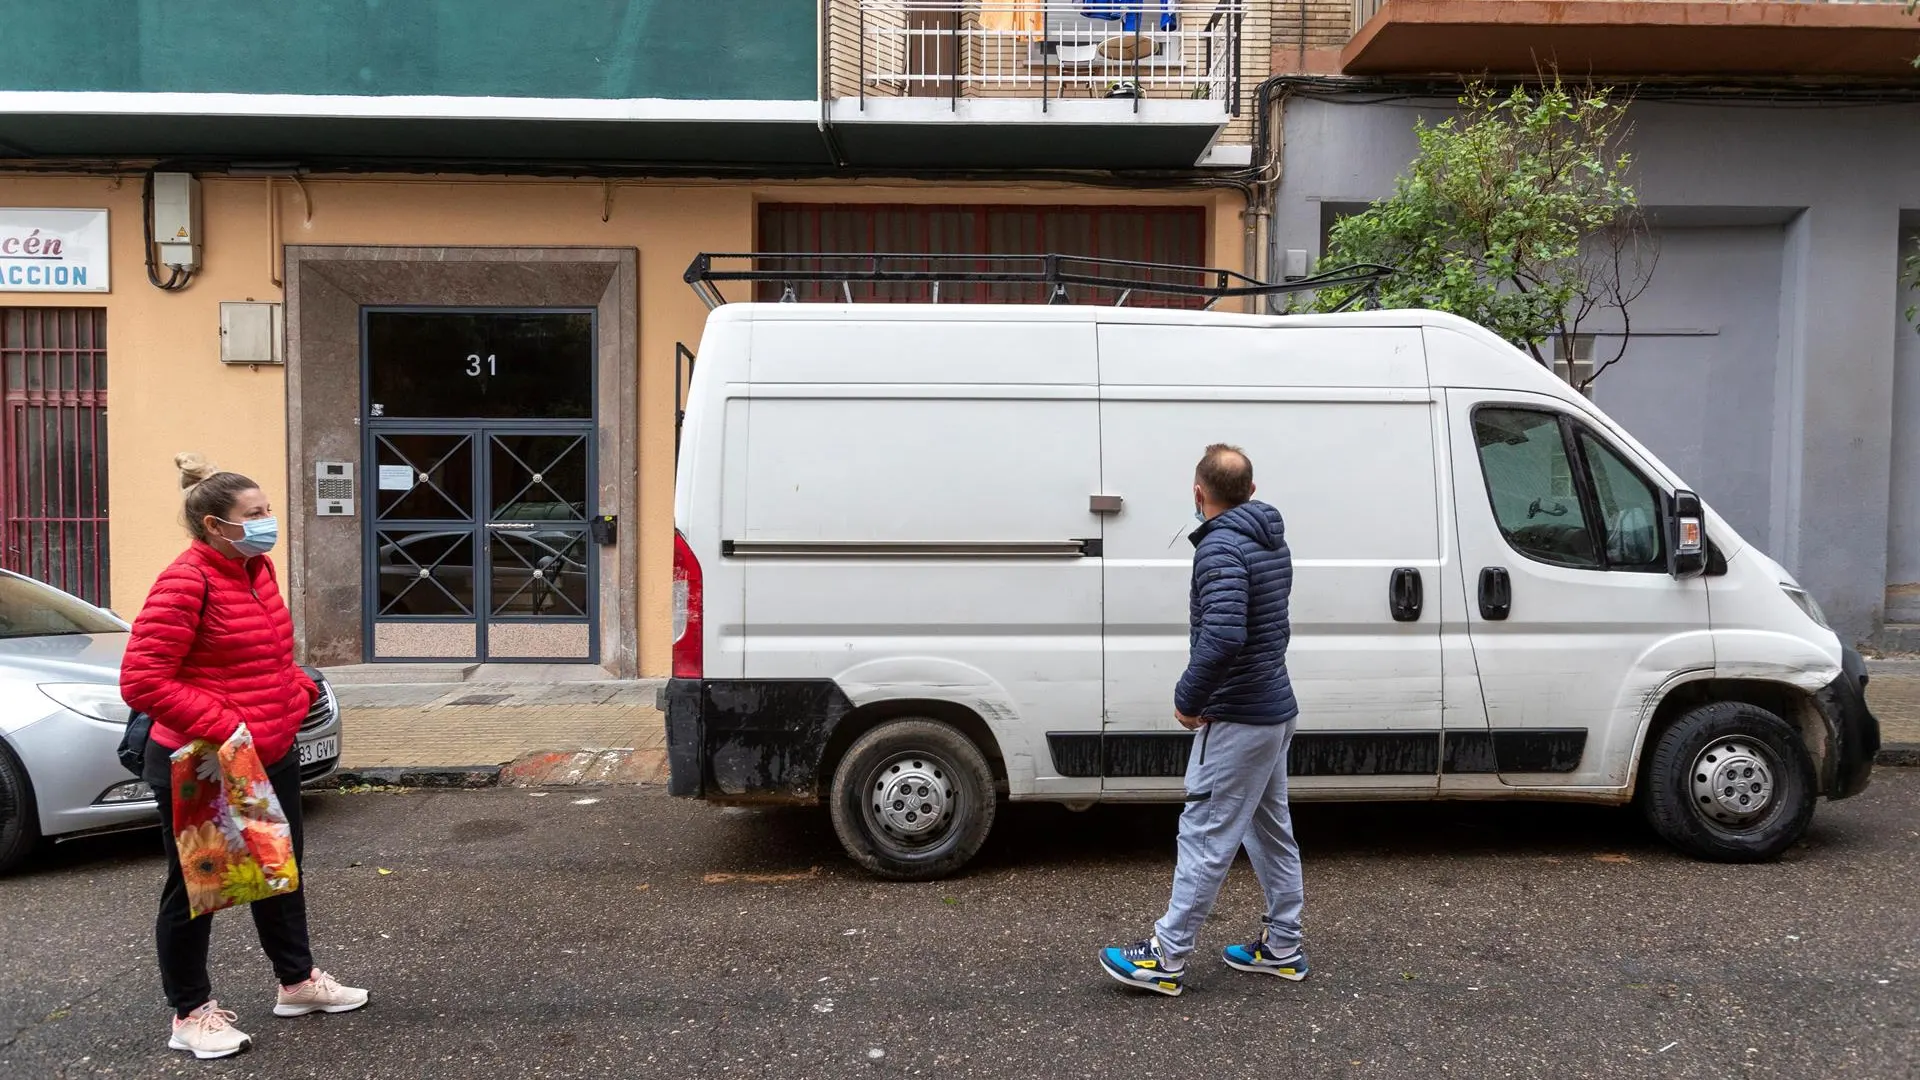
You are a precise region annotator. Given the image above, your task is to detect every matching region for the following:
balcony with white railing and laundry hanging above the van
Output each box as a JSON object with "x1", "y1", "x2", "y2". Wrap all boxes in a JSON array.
[{"x1": 824, "y1": 0, "x2": 1267, "y2": 169}]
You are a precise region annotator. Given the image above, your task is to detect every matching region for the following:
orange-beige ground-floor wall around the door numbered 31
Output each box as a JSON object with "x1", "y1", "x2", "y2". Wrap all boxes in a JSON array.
[{"x1": 0, "y1": 177, "x2": 1242, "y2": 675}]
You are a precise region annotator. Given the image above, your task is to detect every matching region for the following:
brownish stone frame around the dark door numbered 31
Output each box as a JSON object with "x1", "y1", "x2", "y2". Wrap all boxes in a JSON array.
[{"x1": 286, "y1": 244, "x2": 645, "y2": 678}]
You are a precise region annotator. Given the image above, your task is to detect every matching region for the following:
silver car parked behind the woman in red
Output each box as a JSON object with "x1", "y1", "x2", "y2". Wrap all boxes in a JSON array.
[{"x1": 0, "y1": 571, "x2": 340, "y2": 874}]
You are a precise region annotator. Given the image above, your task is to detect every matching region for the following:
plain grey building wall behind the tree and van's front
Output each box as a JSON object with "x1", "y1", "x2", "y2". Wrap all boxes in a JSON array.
[{"x1": 1273, "y1": 98, "x2": 1920, "y2": 640}]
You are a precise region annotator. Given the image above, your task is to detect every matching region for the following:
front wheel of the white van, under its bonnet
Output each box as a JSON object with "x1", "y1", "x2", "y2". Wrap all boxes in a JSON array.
[{"x1": 1640, "y1": 701, "x2": 1818, "y2": 863}]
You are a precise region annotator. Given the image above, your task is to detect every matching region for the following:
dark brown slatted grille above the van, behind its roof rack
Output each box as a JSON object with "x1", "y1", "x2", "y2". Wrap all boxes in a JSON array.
[{"x1": 755, "y1": 204, "x2": 1208, "y2": 307}]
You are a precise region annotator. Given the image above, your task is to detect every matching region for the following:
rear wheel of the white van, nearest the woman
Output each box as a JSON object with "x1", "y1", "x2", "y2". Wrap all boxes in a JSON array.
[{"x1": 829, "y1": 721, "x2": 998, "y2": 880}]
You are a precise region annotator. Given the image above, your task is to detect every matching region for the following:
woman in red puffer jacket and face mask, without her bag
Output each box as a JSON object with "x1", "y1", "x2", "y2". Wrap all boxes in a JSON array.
[{"x1": 121, "y1": 454, "x2": 367, "y2": 1057}]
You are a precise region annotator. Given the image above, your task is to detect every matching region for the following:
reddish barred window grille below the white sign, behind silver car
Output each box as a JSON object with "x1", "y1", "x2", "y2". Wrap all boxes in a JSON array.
[{"x1": 0, "y1": 307, "x2": 108, "y2": 605}]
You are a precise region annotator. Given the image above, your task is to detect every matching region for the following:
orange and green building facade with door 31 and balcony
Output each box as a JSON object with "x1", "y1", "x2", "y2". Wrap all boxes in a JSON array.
[{"x1": 0, "y1": 0, "x2": 1273, "y2": 675}]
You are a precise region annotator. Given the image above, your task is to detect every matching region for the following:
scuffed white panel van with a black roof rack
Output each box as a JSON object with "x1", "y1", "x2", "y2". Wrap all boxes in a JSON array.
[{"x1": 662, "y1": 304, "x2": 1880, "y2": 878}]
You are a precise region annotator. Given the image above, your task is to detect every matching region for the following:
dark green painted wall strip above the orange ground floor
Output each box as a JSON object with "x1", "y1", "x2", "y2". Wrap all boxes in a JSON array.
[{"x1": 0, "y1": 0, "x2": 818, "y2": 100}]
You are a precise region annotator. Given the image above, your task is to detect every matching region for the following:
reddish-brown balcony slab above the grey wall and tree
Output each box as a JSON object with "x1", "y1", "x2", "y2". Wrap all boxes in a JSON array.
[{"x1": 1340, "y1": 0, "x2": 1920, "y2": 81}]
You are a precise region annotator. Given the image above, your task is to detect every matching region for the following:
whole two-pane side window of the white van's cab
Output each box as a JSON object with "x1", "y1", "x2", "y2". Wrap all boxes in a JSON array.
[{"x1": 1473, "y1": 407, "x2": 1667, "y2": 573}]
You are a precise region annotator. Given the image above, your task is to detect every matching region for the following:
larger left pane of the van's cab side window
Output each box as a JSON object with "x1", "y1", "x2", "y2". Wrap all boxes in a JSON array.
[{"x1": 1473, "y1": 409, "x2": 1601, "y2": 569}]
